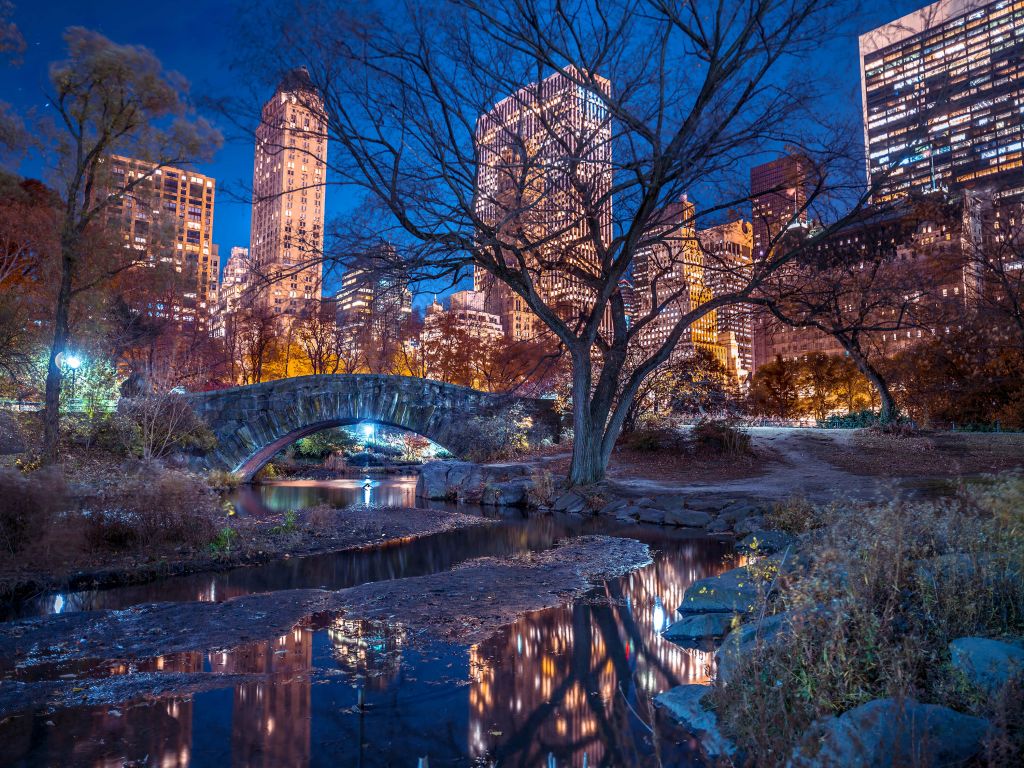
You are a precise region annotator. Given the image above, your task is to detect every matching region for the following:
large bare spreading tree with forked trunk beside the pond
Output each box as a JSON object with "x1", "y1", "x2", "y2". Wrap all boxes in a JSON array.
[{"x1": 241, "y1": 0, "x2": 880, "y2": 483}]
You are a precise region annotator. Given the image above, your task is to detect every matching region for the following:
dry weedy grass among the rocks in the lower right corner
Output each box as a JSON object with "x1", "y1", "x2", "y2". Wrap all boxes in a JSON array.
[{"x1": 714, "y1": 475, "x2": 1024, "y2": 766}]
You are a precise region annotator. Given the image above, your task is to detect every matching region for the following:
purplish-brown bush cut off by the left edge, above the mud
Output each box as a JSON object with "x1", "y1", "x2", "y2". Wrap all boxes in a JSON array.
[{"x1": 0, "y1": 469, "x2": 67, "y2": 555}]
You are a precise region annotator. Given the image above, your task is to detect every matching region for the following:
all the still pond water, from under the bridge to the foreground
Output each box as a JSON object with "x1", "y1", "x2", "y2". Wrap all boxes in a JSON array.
[{"x1": 0, "y1": 478, "x2": 731, "y2": 768}]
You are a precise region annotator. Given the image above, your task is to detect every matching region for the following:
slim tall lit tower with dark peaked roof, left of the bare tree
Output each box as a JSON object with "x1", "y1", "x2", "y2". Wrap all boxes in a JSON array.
[{"x1": 250, "y1": 68, "x2": 328, "y2": 317}]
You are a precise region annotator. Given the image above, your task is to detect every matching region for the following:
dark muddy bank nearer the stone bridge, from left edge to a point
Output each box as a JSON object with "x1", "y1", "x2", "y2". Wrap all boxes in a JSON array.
[{"x1": 0, "y1": 507, "x2": 492, "y2": 605}]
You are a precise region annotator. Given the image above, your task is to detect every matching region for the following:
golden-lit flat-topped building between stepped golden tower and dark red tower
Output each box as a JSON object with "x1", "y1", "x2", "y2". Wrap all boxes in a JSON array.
[{"x1": 697, "y1": 220, "x2": 754, "y2": 381}]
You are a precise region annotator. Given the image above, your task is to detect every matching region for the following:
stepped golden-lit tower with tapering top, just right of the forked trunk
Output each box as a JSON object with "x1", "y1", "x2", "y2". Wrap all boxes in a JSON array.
[{"x1": 633, "y1": 198, "x2": 725, "y2": 364}]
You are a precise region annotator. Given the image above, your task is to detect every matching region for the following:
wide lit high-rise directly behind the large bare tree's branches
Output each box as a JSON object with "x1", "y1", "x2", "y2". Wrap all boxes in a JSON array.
[{"x1": 473, "y1": 69, "x2": 611, "y2": 340}]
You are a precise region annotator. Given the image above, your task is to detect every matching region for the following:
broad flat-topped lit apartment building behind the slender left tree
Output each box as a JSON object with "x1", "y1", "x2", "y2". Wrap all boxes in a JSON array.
[{"x1": 110, "y1": 155, "x2": 220, "y2": 330}]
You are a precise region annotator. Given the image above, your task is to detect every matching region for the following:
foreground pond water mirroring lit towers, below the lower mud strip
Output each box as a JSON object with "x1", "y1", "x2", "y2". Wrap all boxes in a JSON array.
[{"x1": 0, "y1": 536, "x2": 728, "y2": 768}]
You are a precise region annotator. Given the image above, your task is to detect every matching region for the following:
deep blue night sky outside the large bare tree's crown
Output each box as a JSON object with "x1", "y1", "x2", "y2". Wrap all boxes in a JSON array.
[{"x1": 0, "y1": 0, "x2": 927, "y2": 304}]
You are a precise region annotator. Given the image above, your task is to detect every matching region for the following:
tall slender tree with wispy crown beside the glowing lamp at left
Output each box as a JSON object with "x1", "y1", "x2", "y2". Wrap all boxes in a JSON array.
[{"x1": 33, "y1": 28, "x2": 219, "y2": 461}]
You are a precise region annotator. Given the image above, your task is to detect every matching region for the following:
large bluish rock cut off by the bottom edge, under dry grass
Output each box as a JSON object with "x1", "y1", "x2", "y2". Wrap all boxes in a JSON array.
[{"x1": 786, "y1": 698, "x2": 988, "y2": 768}]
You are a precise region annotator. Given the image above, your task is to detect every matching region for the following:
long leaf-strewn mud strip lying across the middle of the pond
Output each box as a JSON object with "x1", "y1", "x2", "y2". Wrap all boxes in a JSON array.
[{"x1": 0, "y1": 536, "x2": 650, "y2": 685}]
